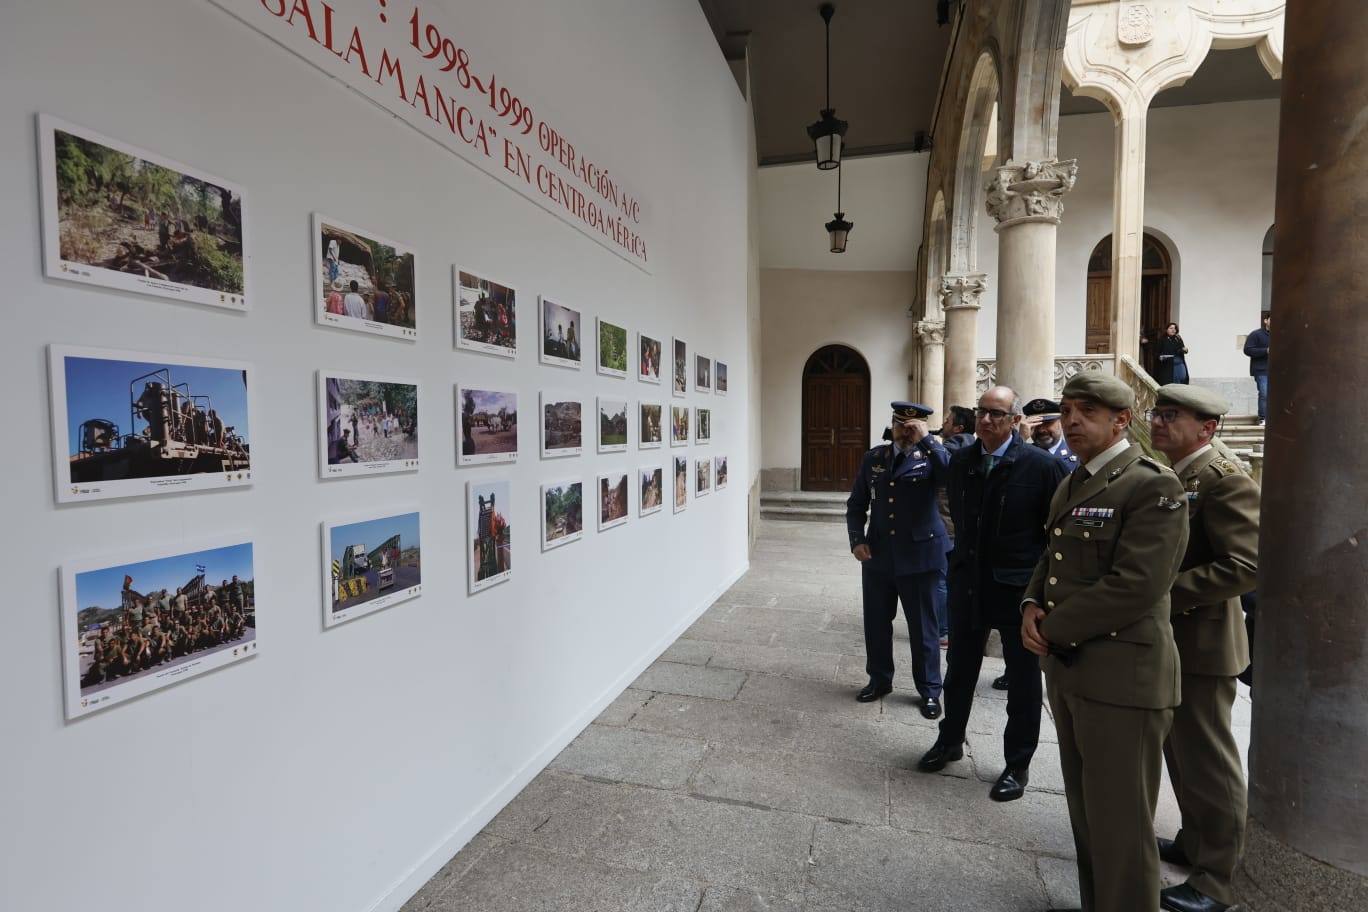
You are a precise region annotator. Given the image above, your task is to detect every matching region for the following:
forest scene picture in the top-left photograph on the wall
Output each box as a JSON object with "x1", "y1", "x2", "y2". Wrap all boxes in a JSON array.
[{"x1": 53, "y1": 129, "x2": 244, "y2": 295}]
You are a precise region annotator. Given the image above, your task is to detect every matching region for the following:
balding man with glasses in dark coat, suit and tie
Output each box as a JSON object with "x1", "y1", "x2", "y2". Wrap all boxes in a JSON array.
[{"x1": 918, "y1": 387, "x2": 1068, "y2": 801}]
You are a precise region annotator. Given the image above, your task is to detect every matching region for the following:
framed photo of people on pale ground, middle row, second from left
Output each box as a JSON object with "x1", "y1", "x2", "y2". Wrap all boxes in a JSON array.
[{"x1": 319, "y1": 371, "x2": 419, "y2": 479}]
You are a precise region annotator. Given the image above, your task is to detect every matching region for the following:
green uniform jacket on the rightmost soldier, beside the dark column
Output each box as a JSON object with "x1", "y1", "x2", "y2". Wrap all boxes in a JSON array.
[{"x1": 1171, "y1": 450, "x2": 1259, "y2": 677}]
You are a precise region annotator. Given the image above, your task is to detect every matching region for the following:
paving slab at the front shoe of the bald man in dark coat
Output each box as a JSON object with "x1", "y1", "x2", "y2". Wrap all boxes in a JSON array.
[{"x1": 889, "y1": 770, "x2": 1074, "y2": 859}]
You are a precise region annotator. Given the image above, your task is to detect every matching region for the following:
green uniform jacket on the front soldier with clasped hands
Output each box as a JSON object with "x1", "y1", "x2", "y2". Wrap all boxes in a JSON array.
[{"x1": 1025, "y1": 444, "x2": 1187, "y2": 710}]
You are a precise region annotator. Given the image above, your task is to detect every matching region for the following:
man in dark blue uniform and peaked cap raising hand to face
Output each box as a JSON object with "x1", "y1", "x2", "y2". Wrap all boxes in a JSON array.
[{"x1": 845, "y1": 402, "x2": 949, "y2": 719}]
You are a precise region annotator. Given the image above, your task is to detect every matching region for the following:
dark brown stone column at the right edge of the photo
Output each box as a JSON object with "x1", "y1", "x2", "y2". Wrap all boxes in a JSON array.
[{"x1": 1235, "y1": 0, "x2": 1368, "y2": 912}]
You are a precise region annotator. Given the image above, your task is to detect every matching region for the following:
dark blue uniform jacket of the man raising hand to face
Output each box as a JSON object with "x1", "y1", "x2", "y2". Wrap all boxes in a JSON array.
[{"x1": 845, "y1": 436, "x2": 949, "y2": 576}]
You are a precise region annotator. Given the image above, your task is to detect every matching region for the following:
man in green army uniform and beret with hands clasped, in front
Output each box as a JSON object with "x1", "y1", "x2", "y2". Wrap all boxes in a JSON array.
[{"x1": 1022, "y1": 372, "x2": 1187, "y2": 912}]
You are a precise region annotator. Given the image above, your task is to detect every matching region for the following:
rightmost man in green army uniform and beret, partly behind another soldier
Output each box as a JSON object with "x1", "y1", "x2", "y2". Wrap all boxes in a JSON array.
[{"x1": 1149, "y1": 383, "x2": 1259, "y2": 912}]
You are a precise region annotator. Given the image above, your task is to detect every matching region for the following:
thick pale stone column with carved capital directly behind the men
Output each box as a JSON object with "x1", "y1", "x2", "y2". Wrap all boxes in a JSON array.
[{"x1": 988, "y1": 160, "x2": 1078, "y2": 399}]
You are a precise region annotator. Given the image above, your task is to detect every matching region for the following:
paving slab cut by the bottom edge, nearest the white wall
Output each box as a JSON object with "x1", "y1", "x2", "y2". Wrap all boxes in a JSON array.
[{"x1": 430, "y1": 844, "x2": 703, "y2": 912}]
